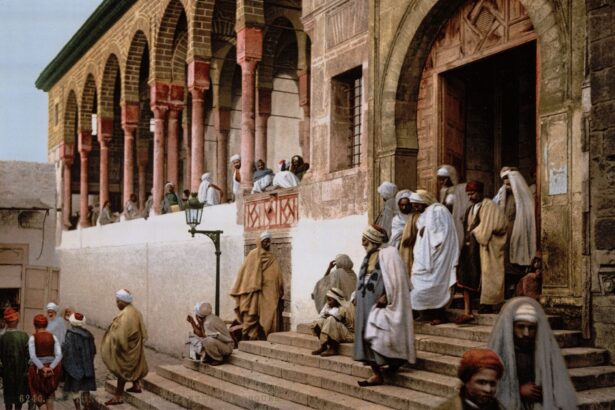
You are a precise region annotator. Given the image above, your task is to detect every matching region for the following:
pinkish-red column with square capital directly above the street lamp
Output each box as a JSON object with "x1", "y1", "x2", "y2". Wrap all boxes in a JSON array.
[{"x1": 188, "y1": 60, "x2": 209, "y2": 192}]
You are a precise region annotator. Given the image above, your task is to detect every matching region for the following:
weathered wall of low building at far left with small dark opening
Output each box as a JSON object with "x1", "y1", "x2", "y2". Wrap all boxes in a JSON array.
[{"x1": 0, "y1": 161, "x2": 59, "y2": 267}]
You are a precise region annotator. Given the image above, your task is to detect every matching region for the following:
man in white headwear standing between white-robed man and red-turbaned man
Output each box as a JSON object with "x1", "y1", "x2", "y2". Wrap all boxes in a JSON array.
[{"x1": 437, "y1": 164, "x2": 472, "y2": 249}]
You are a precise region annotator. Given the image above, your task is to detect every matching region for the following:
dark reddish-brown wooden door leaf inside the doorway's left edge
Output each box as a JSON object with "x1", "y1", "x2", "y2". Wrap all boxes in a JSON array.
[{"x1": 440, "y1": 76, "x2": 466, "y2": 178}]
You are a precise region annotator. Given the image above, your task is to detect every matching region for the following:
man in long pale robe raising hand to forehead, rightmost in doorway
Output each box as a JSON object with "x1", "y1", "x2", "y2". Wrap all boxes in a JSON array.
[{"x1": 493, "y1": 167, "x2": 536, "y2": 297}]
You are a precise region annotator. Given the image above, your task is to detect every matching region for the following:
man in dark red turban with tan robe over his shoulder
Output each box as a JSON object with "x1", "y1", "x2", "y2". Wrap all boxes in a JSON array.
[{"x1": 455, "y1": 181, "x2": 507, "y2": 324}]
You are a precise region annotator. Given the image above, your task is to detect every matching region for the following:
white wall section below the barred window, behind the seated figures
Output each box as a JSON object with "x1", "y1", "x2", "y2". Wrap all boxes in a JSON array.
[{"x1": 291, "y1": 214, "x2": 368, "y2": 329}]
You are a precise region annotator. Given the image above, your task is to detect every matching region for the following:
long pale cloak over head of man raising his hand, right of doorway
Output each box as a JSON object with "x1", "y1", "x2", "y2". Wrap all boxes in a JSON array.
[{"x1": 493, "y1": 169, "x2": 536, "y2": 266}]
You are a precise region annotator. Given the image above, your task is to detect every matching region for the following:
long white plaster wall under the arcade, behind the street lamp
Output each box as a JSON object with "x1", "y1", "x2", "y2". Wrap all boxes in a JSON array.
[{"x1": 58, "y1": 204, "x2": 244, "y2": 355}]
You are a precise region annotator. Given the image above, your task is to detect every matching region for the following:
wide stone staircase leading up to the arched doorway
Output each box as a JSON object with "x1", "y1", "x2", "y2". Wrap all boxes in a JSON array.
[{"x1": 96, "y1": 311, "x2": 615, "y2": 410}]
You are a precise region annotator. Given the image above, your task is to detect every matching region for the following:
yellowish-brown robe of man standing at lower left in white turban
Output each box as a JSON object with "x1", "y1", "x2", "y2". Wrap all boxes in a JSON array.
[{"x1": 100, "y1": 304, "x2": 149, "y2": 381}]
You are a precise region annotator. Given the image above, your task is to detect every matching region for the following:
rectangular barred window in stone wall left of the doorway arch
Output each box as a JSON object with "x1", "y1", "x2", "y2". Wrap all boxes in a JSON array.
[{"x1": 329, "y1": 67, "x2": 363, "y2": 171}]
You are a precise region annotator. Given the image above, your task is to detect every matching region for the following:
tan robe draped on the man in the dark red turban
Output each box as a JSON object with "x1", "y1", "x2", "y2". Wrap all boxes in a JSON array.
[{"x1": 472, "y1": 198, "x2": 508, "y2": 305}]
